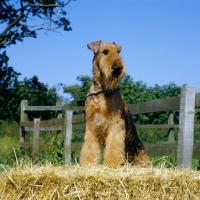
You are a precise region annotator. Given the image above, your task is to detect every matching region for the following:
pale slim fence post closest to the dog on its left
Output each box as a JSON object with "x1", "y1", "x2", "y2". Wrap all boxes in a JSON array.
[{"x1": 64, "y1": 110, "x2": 73, "y2": 165}]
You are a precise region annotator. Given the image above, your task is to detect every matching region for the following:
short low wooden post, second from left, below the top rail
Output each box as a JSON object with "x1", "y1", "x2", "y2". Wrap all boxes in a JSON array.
[{"x1": 33, "y1": 118, "x2": 40, "y2": 153}]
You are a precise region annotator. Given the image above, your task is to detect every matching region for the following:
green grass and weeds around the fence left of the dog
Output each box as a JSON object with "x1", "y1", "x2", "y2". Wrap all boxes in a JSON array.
[{"x1": 0, "y1": 122, "x2": 84, "y2": 168}]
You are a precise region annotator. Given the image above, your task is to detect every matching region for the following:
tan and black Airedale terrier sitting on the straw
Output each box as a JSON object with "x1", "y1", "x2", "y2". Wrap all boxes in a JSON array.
[{"x1": 80, "y1": 41, "x2": 150, "y2": 168}]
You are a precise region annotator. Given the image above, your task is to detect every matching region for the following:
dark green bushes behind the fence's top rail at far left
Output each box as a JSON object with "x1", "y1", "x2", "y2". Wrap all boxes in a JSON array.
[{"x1": 0, "y1": 73, "x2": 59, "y2": 122}]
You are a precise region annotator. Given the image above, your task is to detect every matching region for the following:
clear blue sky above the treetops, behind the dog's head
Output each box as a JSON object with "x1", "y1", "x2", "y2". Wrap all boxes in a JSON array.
[{"x1": 1, "y1": 0, "x2": 200, "y2": 96}]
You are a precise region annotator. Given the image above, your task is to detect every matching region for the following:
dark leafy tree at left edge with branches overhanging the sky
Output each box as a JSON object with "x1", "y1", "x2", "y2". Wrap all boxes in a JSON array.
[{"x1": 0, "y1": 0, "x2": 71, "y2": 121}]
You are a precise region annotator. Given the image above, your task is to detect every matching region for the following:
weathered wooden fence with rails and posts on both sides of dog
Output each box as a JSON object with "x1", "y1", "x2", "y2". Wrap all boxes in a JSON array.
[{"x1": 20, "y1": 88, "x2": 200, "y2": 167}]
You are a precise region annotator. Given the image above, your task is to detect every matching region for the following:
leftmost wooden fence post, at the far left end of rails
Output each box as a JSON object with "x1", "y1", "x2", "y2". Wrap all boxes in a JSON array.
[{"x1": 19, "y1": 100, "x2": 28, "y2": 148}]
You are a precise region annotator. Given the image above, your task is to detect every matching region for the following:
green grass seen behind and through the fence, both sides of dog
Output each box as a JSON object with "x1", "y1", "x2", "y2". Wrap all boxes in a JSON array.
[{"x1": 0, "y1": 122, "x2": 200, "y2": 171}]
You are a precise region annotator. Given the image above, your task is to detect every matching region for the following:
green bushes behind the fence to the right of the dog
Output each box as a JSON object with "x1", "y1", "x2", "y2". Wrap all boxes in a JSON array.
[{"x1": 119, "y1": 75, "x2": 181, "y2": 124}]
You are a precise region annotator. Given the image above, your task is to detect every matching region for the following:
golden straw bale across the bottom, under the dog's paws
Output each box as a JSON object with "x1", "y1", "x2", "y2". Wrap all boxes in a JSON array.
[{"x1": 0, "y1": 164, "x2": 200, "y2": 200}]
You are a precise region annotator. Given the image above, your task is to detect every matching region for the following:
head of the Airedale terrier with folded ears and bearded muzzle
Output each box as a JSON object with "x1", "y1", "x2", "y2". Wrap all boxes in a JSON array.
[{"x1": 87, "y1": 41, "x2": 126, "y2": 90}]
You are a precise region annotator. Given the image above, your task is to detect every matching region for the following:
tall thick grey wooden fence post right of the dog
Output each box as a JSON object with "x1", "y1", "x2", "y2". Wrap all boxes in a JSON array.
[{"x1": 177, "y1": 87, "x2": 196, "y2": 168}]
